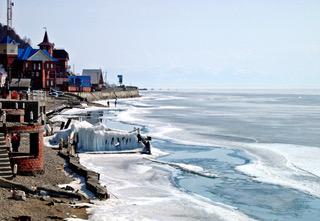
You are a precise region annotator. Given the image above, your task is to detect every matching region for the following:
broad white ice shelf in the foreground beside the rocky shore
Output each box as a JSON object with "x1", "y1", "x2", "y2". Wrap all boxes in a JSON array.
[{"x1": 53, "y1": 96, "x2": 252, "y2": 220}]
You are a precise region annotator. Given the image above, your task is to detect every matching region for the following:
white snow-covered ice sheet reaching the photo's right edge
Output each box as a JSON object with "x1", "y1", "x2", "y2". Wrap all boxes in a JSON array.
[{"x1": 236, "y1": 143, "x2": 320, "y2": 197}]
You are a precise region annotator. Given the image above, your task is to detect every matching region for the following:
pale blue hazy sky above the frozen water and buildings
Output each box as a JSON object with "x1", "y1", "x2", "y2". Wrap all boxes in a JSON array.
[{"x1": 0, "y1": 0, "x2": 320, "y2": 88}]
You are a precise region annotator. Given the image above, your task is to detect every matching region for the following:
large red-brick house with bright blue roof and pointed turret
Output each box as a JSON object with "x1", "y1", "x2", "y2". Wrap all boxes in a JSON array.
[{"x1": 0, "y1": 31, "x2": 69, "y2": 90}]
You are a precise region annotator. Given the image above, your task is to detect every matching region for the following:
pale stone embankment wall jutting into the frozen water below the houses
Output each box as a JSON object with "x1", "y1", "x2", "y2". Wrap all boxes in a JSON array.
[{"x1": 69, "y1": 87, "x2": 140, "y2": 102}]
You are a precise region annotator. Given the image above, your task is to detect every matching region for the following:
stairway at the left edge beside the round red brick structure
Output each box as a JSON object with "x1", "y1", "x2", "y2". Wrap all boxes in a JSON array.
[{"x1": 0, "y1": 133, "x2": 12, "y2": 179}]
